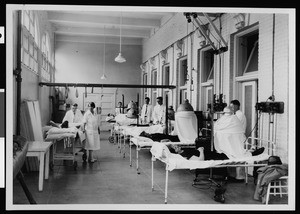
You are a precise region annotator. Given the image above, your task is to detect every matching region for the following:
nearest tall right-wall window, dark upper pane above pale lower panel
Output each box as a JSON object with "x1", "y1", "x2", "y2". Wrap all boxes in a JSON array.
[{"x1": 232, "y1": 24, "x2": 259, "y2": 140}]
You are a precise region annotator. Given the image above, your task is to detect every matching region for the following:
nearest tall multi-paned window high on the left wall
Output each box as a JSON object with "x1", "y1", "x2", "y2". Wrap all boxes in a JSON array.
[{"x1": 21, "y1": 10, "x2": 39, "y2": 74}]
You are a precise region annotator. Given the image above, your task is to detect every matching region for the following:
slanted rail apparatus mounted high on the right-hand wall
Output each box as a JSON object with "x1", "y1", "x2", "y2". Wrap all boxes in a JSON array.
[{"x1": 183, "y1": 13, "x2": 228, "y2": 55}]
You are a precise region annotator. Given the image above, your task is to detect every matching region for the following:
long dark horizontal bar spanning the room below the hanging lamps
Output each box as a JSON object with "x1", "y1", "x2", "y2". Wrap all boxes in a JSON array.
[{"x1": 39, "y1": 82, "x2": 176, "y2": 89}]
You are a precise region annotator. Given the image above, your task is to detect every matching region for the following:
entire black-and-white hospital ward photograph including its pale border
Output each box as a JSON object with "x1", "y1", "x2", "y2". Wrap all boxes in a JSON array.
[{"x1": 6, "y1": 4, "x2": 296, "y2": 210}]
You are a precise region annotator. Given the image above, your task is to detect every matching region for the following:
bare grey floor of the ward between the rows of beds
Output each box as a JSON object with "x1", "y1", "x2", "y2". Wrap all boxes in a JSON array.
[{"x1": 13, "y1": 132, "x2": 287, "y2": 208}]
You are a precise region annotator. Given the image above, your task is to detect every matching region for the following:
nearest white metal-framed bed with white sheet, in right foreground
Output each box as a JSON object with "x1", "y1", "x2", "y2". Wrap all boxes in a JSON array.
[{"x1": 150, "y1": 137, "x2": 275, "y2": 204}]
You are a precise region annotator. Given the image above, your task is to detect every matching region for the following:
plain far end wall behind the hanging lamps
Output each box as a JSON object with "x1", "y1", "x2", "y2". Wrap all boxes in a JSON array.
[{"x1": 55, "y1": 42, "x2": 142, "y2": 110}]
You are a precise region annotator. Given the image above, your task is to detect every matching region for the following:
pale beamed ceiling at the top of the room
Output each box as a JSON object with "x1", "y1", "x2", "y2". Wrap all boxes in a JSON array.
[{"x1": 48, "y1": 11, "x2": 176, "y2": 45}]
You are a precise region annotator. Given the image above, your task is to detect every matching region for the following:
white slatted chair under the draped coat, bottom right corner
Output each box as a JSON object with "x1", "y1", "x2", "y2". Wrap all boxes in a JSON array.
[{"x1": 266, "y1": 176, "x2": 288, "y2": 204}]
